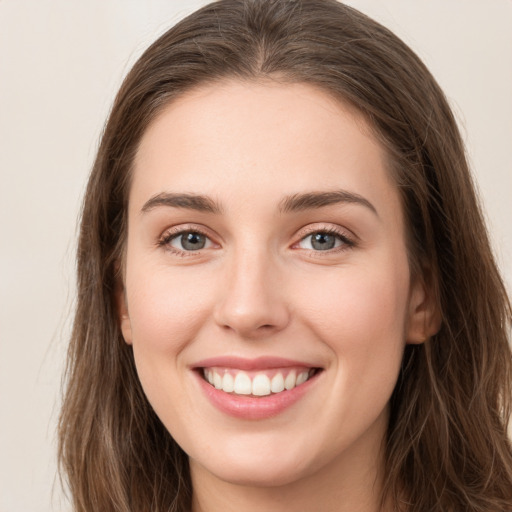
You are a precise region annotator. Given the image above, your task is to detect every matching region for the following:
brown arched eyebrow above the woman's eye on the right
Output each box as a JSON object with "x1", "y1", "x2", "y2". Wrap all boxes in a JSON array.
[{"x1": 280, "y1": 190, "x2": 379, "y2": 217}]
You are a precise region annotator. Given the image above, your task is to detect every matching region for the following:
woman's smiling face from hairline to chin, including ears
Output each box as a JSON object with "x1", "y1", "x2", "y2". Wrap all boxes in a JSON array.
[{"x1": 119, "y1": 81, "x2": 425, "y2": 485}]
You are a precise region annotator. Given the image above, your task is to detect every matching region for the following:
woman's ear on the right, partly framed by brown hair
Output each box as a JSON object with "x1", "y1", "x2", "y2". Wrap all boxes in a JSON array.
[{"x1": 405, "y1": 277, "x2": 441, "y2": 344}]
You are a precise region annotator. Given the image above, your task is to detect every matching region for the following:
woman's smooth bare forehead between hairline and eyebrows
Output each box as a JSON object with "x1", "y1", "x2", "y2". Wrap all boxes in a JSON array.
[{"x1": 130, "y1": 81, "x2": 397, "y2": 221}]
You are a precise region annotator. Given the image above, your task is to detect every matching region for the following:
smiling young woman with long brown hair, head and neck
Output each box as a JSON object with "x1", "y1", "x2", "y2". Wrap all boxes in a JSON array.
[{"x1": 60, "y1": 0, "x2": 512, "y2": 512}]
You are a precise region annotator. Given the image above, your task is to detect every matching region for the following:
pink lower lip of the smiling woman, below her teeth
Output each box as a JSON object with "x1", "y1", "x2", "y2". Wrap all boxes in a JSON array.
[{"x1": 196, "y1": 372, "x2": 321, "y2": 420}]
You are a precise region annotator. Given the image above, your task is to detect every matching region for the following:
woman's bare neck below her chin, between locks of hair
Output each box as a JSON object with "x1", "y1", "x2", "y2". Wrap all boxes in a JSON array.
[{"x1": 190, "y1": 416, "x2": 391, "y2": 512}]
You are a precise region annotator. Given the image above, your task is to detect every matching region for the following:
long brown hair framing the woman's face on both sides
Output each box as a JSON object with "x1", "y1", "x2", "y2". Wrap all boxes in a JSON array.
[{"x1": 59, "y1": 0, "x2": 512, "y2": 512}]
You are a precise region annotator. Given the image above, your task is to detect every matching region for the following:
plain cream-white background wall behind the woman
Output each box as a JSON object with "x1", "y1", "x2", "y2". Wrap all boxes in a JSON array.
[{"x1": 0, "y1": 0, "x2": 512, "y2": 512}]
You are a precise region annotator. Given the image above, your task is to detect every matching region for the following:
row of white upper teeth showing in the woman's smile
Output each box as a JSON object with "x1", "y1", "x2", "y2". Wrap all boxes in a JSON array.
[{"x1": 203, "y1": 368, "x2": 310, "y2": 396}]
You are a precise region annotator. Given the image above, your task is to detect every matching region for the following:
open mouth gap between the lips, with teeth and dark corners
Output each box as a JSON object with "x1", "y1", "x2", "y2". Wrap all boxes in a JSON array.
[{"x1": 200, "y1": 367, "x2": 321, "y2": 397}]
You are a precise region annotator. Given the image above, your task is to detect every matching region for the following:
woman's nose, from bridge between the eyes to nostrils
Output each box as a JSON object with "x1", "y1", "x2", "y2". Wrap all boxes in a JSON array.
[{"x1": 214, "y1": 250, "x2": 290, "y2": 339}]
